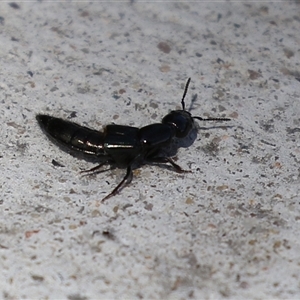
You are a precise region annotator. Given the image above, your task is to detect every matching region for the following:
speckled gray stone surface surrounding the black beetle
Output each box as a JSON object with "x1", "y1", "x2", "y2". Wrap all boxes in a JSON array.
[{"x1": 0, "y1": 1, "x2": 300, "y2": 300}]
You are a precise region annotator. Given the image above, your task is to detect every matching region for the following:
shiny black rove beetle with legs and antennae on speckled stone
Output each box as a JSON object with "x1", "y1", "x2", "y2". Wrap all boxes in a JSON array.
[{"x1": 36, "y1": 78, "x2": 230, "y2": 202}]
